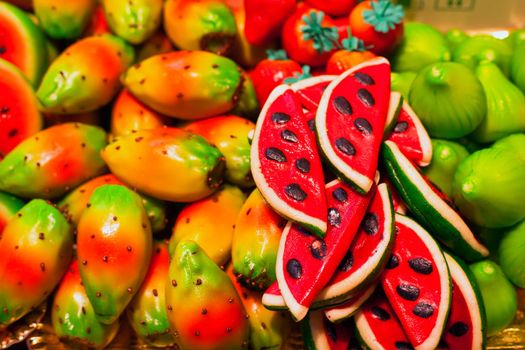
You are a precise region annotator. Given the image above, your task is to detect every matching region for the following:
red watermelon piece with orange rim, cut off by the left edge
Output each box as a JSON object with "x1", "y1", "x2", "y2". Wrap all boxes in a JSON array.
[{"x1": 0, "y1": 59, "x2": 42, "y2": 160}]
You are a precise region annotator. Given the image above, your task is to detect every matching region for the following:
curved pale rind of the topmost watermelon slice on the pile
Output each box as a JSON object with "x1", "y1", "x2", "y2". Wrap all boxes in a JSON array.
[{"x1": 315, "y1": 57, "x2": 390, "y2": 194}]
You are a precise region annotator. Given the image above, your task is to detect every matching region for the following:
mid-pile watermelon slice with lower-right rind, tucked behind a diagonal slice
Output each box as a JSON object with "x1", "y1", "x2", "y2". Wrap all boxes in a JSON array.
[{"x1": 315, "y1": 184, "x2": 394, "y2": 307}]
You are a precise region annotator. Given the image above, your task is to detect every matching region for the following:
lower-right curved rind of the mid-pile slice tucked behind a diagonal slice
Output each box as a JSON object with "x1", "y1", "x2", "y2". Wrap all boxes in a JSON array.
[{"x1": 312, "y1": 184, "x2": 395, "y2": 308}]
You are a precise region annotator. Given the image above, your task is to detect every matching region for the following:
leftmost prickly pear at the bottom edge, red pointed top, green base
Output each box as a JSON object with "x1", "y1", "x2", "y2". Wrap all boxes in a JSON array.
[{"x1": 51, "y1": 259, "x2": 119, "y2": 349}]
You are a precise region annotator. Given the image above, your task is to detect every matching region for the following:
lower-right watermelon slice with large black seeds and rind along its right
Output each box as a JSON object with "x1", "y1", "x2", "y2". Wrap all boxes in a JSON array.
[{"x1": 381, "y1": 214, "x2": 451, "y2": 350}]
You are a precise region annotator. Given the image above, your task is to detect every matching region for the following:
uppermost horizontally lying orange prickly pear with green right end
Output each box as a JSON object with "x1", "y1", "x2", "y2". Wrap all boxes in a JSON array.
[{"x1": 123, "y1": 51, "x2": 242, "y2": 120}]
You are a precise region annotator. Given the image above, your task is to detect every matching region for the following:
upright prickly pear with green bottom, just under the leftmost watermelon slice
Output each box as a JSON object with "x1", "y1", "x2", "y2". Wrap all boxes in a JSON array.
[{"x1": 232, "y1": 189, "x2": 286, "y2": 290}]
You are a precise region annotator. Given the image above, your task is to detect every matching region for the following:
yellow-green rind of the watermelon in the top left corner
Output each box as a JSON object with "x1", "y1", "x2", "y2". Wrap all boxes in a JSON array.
[{"x1": 0, "y1": 2, "x2": 48, "y2": 87}]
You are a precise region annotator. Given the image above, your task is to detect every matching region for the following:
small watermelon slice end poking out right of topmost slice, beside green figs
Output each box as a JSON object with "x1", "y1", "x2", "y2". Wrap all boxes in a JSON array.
[{"x1": 387, "y1": 101, "x2": 432, "y2": 166}]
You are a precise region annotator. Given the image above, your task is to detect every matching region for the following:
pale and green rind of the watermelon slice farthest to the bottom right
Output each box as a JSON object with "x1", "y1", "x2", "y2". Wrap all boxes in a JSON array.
[{"x1": 445, "y1": 252, "x2": 487, "y2": 350}]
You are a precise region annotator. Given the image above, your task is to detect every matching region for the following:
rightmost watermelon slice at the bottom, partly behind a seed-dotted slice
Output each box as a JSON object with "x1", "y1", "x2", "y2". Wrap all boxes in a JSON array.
[{"x1": 442, "y1": 253, "x2": 487, "y2": 350}]
